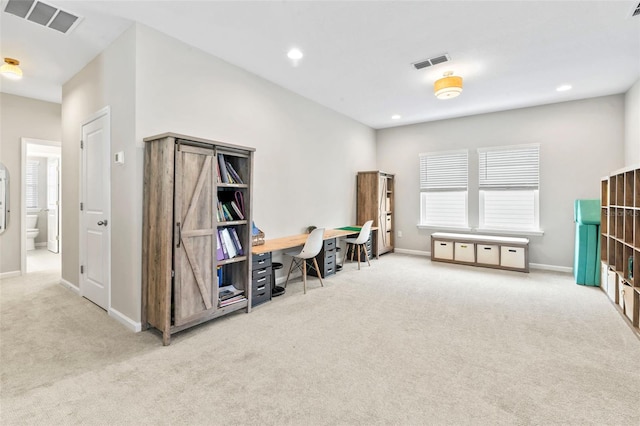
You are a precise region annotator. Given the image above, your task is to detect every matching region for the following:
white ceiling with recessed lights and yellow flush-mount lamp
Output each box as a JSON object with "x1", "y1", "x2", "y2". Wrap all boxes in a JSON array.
[{"x1": 0, "y1": 0, "x2": 640, "y2": 129}]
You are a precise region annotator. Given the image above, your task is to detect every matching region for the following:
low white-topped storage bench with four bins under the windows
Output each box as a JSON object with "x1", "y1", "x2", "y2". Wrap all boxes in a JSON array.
[{"x1": 431, "y1": 232, "x2": 529, "y2": 272}]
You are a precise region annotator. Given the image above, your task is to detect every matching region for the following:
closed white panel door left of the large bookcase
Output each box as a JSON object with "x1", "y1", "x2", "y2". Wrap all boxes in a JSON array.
[{"x1": 80, "y1": 111, "x2": 111, "y2": 310}]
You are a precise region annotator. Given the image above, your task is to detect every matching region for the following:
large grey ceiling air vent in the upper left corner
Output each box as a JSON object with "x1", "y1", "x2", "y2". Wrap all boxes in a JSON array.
[{"x1": 4, "y1": 0, "x2": 80, "y2": 34}]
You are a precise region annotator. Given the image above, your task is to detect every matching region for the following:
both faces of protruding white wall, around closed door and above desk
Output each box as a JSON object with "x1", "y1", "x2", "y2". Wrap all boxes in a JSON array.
[{"x1": 62, "y1": 24, "x2": 376, "y2": 321}]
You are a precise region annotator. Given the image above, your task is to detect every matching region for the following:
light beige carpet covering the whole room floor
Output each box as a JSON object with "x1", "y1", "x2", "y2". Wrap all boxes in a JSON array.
[{"x1": 0, "y1": 254, "x2": 640, "y2": 426}]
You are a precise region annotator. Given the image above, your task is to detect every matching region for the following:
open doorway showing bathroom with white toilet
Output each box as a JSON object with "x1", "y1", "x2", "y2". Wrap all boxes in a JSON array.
[{"x1": 20, "y1": 138, "x2": 62, "y2": 273}]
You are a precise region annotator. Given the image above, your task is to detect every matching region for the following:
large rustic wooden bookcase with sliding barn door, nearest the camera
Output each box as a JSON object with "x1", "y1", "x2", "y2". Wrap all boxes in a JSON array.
[{"x1": 142, "y1": 133, "x2": 254, "y2": 345}]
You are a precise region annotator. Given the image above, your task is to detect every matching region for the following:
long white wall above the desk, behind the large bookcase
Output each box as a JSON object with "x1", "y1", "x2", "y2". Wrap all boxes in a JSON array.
[{"x1": 136, "y1": 26, "x2": 376, "y2": 238}]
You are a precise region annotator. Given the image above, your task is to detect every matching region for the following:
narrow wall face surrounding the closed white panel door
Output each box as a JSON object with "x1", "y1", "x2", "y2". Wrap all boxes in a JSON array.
[{"x1": 62, "y1": 23, "x2": 140, "y2": 320}]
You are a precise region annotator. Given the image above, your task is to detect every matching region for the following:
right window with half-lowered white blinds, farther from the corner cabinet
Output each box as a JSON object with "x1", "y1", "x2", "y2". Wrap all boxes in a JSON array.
[{"x1": 478, "y1": 145, "x2": 540, "y2": 231}]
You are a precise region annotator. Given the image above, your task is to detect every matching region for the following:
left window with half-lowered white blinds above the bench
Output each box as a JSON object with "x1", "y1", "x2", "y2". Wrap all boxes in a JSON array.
[{"x1": 419, "y1": 150, "x2": 469, "y2": 228}]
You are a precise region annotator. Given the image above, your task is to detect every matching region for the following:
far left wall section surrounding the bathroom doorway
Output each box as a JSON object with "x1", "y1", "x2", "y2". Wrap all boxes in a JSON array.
[{"x1": 0, "y1": 93, "x2": 61, "y2": 274}]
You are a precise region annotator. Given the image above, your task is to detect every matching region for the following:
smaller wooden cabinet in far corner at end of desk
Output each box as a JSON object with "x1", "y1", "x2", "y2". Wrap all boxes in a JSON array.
[{"x1": 356, "y1": 170, "x2": 395, "y2": 256}]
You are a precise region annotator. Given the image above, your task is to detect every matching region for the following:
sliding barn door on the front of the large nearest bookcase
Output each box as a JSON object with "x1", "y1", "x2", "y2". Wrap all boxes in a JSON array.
[{"x1": 173, "y1": 145, "x2": 217, "y2": 326}]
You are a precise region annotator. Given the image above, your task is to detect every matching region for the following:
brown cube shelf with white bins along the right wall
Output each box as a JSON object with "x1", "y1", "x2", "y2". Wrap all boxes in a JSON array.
[{"x1": 600, "y1": 167, "x2": 640, "y2": 335}]
